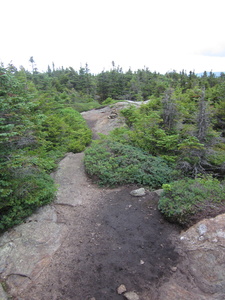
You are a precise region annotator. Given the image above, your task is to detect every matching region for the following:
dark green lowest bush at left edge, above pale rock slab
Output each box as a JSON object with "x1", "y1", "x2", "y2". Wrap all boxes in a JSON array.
[{"x1": 0, "y1": 169, "x2": 56, "y2": 232}]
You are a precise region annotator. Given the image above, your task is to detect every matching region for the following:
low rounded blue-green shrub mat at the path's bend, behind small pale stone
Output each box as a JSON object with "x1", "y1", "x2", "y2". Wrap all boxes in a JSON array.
[{"x1": 85, "y1": 139, "x2": 175, "y2": 189}]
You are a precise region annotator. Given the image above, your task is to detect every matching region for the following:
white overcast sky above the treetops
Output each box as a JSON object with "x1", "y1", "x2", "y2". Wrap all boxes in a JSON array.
[{"x1": 0, "y1": 0, "x2": 225, "y2": 73}]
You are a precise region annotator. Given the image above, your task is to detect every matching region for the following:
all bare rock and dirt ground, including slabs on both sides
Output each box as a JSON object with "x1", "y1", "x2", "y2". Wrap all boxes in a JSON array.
[{"x1": 0, "y1": 103, "x2": 225, "y2": 300}]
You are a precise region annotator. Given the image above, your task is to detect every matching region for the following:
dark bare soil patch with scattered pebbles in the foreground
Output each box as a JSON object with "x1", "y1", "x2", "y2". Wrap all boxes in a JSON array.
[{"x1": 18, "y1": 186, "x2": 179, "y2": 300}]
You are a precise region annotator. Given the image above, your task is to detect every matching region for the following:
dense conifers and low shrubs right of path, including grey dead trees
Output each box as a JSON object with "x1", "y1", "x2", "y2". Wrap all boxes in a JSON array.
[{"x1": 85, "y1": 69, "x2": 225, "y2": 227}]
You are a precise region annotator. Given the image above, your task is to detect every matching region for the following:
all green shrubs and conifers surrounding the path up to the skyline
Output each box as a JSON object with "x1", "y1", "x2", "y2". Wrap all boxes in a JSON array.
[{"x1": 0, "y1": 60, "x2": 225, "y2": 231}]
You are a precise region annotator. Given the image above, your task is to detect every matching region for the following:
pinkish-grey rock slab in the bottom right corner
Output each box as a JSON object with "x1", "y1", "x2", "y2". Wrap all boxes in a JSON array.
[{"x1": 159, "y1": 214, "x2": 225, "y2": 300}]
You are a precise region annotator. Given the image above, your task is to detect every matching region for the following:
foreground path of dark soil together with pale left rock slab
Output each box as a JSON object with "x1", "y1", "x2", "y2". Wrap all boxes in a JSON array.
[{"x1": 0, "y1": 153, "x2": 179, "y2": 300}]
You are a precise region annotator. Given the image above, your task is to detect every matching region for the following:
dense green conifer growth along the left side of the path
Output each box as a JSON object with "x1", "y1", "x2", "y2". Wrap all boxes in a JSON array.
[{"x1": 0, "y1": 68, "x2": 91, "y2": 231}]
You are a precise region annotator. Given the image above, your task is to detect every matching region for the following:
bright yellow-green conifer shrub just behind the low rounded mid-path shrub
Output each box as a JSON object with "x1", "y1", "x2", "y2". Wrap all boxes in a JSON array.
[{"x1": 110, "y1": 105, "x2": 179, "y2": 162}]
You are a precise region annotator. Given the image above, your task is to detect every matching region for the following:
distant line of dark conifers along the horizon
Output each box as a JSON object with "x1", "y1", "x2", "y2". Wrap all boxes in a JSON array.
[{"x1": 22, "y1": 62, "x2": 225, "y2": 103}]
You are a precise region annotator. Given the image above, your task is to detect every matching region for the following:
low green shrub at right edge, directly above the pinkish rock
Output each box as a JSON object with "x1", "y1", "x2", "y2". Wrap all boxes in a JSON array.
[{"x1": 158, "y1": 176, "x2": 225, "y2": 226}]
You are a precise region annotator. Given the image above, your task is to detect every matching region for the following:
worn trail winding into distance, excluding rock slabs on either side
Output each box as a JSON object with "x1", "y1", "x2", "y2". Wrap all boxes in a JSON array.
[{"x1": 14, "y1": 104, "x2": 180, "y2": 300}]
